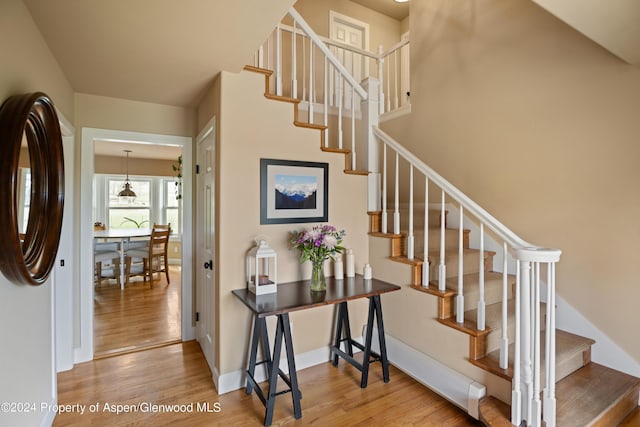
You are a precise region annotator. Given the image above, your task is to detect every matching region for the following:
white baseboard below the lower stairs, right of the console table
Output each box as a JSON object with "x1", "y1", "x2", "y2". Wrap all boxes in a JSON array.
[{"x1": 364, "y1": 328, "x2": 487, "y2": 419}]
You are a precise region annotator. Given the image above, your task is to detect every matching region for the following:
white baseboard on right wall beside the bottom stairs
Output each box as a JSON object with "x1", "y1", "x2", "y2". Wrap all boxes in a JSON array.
[{"x1": 556, "y1": 293, "x2": 640, "y2": 377}]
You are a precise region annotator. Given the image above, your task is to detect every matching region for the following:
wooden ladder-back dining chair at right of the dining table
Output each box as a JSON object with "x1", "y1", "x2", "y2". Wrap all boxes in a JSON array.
[{"x1": 125, "y1": 224, "x2": 171, "y2": 284}]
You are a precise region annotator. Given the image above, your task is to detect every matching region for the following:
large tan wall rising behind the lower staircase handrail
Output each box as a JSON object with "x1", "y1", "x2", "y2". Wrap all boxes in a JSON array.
[{"x1": 385, "y1": 0, "x2": 640, "y2": 360}]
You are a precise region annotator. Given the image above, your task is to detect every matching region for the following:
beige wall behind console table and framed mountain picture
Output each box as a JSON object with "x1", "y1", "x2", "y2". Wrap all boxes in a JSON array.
[{"x1": 217, "y1": 72, "x2": 368, "y2": 374}]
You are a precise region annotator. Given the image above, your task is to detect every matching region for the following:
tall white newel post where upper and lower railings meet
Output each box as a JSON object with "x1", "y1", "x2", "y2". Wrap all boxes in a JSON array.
[{"x1": 360, "y1": 77, "x2": 381, "y2": 212}]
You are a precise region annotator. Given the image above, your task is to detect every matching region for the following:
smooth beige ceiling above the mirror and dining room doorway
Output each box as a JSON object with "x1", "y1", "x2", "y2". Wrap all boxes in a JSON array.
[{"x1": 23, "y1": 0, "x2": 294, "y2": 107}]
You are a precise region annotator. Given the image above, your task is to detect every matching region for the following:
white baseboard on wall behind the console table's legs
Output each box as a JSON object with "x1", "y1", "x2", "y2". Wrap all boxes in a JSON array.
[{"x1": 218, "y1": 337, "x2": 362, "y2": 394}]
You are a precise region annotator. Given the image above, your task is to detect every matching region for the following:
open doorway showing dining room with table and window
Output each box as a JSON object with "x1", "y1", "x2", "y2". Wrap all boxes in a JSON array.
[{"x1": 93, "y1": 140, "x2": 183, "y2": 358}]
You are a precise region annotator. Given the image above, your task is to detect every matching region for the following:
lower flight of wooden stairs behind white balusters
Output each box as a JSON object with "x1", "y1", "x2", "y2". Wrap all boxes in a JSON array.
[{"x1": 369, "y1": 210, "x2": 640, "y2": 427}]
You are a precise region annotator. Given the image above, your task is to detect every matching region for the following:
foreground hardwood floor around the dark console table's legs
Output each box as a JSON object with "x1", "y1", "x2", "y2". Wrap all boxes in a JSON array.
[{"x1": 53, "y1": 341, "x2": 481, "y2": 427}]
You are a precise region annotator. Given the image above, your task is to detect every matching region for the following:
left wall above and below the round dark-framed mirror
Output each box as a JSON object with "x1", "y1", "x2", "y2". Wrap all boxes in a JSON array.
[{"x1": 0, "y1": 0, "x2": 74, "y2": 426}]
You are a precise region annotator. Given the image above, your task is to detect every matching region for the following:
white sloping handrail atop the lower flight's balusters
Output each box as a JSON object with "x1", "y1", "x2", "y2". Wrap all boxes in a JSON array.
[{"x1": 373, "y1": 127, "x2": 561, "y2": 262}]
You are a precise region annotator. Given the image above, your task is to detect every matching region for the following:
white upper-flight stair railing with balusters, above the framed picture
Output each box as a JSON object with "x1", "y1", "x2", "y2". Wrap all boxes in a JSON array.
[{"x1": 254, "y1": 8, "x2": 409, "y2": 170}]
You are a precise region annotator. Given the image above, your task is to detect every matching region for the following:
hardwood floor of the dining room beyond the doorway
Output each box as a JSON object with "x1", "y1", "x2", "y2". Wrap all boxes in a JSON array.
[{"x1": 93, "y1": 266, "x2": 182, "y2": 358}]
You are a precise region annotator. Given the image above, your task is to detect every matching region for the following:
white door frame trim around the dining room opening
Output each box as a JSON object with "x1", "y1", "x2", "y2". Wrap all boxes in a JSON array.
[{"x1": 74, "y1": 128, "x2": 195, "y2": 363}]
